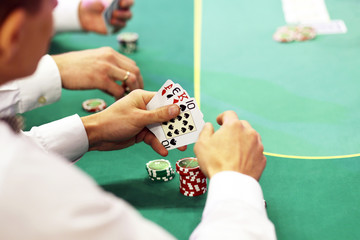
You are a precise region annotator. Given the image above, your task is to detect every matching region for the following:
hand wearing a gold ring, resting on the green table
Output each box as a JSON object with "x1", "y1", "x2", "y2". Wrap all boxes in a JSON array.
[{"x1": 52, "y1": 47, "x2": 144, "y2": 99}]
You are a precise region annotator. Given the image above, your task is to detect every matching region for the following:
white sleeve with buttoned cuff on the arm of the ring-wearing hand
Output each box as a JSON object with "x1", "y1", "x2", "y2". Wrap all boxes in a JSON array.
[{"x1": 0, "y1": 55, "x2": 61, "y2": 116}]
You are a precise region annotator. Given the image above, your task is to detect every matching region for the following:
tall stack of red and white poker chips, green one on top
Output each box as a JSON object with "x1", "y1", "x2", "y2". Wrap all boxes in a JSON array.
[{"x1": 176, "y1": 157, "x2": 207, "y2": 197}]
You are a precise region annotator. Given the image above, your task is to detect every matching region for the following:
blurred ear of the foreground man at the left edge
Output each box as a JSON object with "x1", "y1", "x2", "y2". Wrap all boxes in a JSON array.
[{"x1": 0, "y1": 9, "x2": 27, "y2": 61}]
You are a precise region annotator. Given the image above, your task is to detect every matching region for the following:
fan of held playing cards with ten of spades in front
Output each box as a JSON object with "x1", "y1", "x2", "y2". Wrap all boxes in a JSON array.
[{"x1": 146, "y1": 80, "x2": 205, "y2": 150}]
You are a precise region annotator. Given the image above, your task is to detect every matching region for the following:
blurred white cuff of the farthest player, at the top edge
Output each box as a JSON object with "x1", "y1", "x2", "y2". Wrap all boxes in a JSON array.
[{"x1": 53, "y1": 0, "x2": 82, "y2": 32}]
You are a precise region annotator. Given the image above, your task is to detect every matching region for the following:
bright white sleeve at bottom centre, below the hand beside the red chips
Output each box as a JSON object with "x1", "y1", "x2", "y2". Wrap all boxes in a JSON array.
[{"x1": 190, "y1": 171, "x2": 276, "y2": 240}]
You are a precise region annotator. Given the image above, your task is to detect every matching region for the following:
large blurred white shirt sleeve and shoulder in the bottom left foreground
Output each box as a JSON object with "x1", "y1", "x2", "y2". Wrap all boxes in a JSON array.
[{"x1": 0, "y1": 122, "x2": 174, "y2": 240}]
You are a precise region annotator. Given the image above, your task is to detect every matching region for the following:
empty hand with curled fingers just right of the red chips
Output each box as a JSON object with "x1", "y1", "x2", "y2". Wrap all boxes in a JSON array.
[{"x1": 194, "y1": 111, "x2": 266, "y2": 181}]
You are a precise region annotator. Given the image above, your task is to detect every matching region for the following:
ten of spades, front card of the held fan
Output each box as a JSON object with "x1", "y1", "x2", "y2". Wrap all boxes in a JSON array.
[{"x1": 148, "y1": 98, "x2": 205, "y2": 150}]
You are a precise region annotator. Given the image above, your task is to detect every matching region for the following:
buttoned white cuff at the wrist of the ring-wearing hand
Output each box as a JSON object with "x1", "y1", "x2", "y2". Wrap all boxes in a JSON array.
[{"x1": 15, "y1": 55, "x2": 61, "y2": 113}]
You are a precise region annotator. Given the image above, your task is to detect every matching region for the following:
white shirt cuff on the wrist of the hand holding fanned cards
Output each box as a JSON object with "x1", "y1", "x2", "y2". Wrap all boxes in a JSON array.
[{"x1": 24, "y1": 115, "x2": 89, "y2": 161}]
